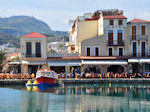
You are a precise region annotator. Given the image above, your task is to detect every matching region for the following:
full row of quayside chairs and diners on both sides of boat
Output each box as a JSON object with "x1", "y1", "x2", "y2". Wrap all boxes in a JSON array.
[{"x1": 0, "y1": 72, "x2": 150, "y2": 80}]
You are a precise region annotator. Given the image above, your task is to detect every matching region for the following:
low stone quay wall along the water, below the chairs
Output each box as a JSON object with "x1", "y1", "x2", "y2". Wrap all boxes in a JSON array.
[{"x1": 0, "y1": 78, "x2": 150, "y2": 85}]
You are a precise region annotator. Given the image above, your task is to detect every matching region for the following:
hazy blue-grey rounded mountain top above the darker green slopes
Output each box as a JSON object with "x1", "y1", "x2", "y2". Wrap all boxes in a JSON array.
[{"x1": 0, "y1": 16, "x2": 55, "y2": 36}]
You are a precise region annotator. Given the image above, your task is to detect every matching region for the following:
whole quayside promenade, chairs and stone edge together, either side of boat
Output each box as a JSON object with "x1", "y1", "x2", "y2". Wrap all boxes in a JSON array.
[{"x1": 0, "y1": 73, "x2": 150, "y2": 85}]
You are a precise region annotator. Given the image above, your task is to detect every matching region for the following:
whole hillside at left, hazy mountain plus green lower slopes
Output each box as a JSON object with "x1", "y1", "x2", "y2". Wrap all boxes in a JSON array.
[{"x1": 0, "y1": 16, "x2": 68, "y2": 47}]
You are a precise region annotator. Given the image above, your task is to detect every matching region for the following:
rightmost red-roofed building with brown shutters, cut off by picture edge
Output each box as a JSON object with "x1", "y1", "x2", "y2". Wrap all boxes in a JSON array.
[{"x1": 127, "y1": 18, "x2": 150, "y2": 73}]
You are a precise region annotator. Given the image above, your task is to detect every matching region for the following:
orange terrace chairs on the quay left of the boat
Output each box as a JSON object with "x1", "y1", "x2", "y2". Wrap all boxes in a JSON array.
[{"x1": 0, "y1": 73, "x2": 35, "y2": 80}]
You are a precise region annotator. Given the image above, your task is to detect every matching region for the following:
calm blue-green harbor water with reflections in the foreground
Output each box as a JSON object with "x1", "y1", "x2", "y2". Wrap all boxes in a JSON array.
[{"x1": 0, "y1": 83, "x2": 150, "y2": 112}]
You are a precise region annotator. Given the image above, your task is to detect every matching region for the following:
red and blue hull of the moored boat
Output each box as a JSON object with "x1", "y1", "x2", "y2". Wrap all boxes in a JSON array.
[{"x1": 36, "y1": 77, "x2": 58, "y2": 87}]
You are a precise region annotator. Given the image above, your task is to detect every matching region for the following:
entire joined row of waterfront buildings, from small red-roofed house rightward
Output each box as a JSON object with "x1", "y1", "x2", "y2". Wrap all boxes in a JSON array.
[{"x1": 21, "y1": 9, "x2": 150, "y2": 73}]
